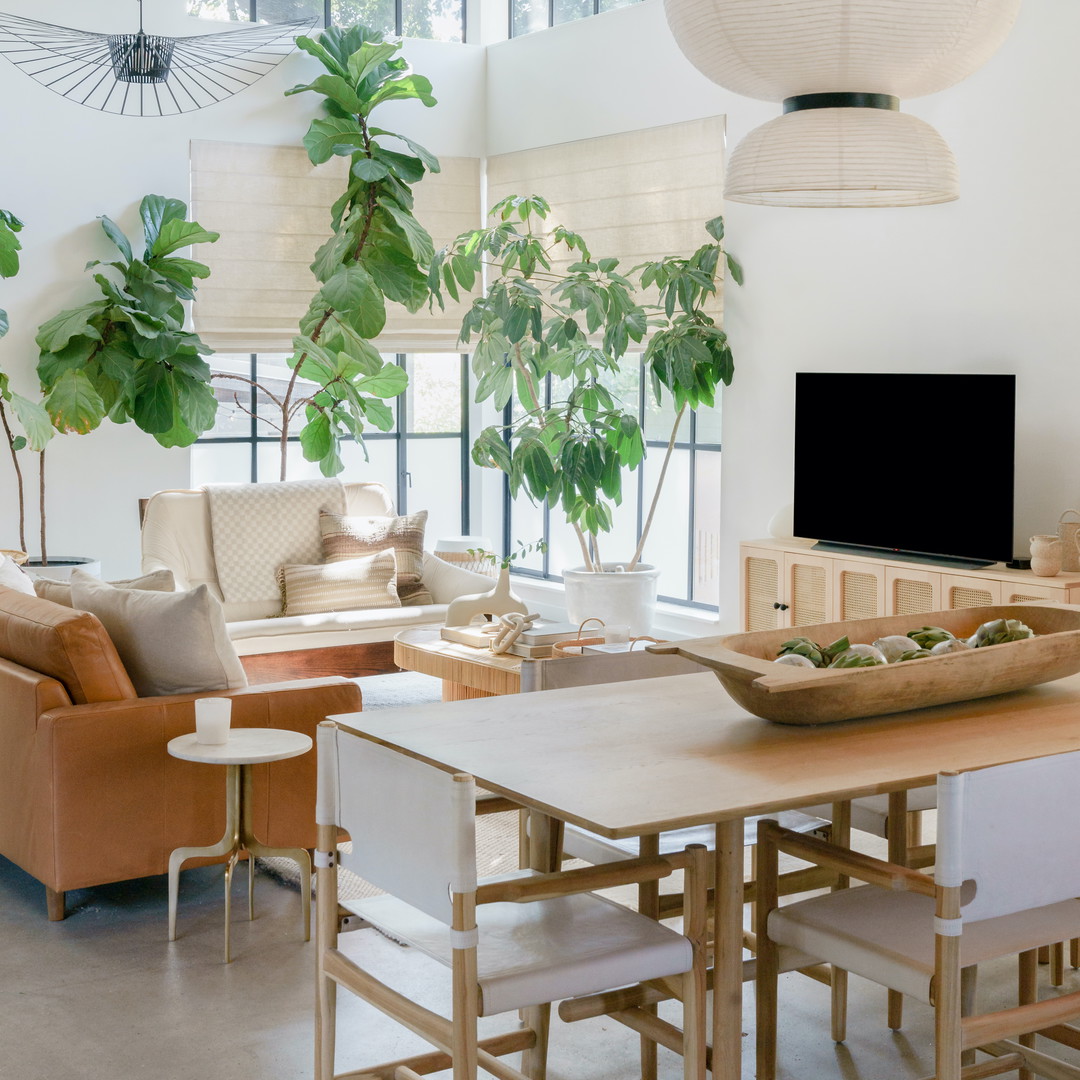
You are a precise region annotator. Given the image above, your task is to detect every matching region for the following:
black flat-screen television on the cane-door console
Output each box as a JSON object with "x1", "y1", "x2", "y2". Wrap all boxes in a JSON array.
[{"x1": 794, "y1": 372, "x2": 1016, "y2": 568}]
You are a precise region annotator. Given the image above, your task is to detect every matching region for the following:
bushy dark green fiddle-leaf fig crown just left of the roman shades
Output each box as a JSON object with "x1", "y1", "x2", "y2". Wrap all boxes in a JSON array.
[{"x1": 37, "y1": 194, "x2": 218, "y2": 446}]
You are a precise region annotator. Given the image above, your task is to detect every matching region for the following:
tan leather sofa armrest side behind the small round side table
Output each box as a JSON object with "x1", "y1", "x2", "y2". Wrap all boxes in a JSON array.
[{"x1": 25, "y1": 678, "x2": 361, "y2": 891}]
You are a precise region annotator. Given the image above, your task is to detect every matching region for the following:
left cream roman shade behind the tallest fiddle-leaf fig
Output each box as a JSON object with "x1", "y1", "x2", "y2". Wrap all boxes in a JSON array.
[{"x1": 191, "y1": 141, "x2": 481, "y2": 352}]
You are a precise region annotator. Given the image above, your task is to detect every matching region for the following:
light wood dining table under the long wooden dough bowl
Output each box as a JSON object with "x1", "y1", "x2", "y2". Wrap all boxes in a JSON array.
[{"x1": 330, "y1": 673, "x2": 1080, "y2": 1080}]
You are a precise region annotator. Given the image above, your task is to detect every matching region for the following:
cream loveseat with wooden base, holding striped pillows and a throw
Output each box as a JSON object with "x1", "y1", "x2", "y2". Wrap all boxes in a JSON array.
[{"x1": 143, "y1": 483, "x2": 494, "y2": 683}]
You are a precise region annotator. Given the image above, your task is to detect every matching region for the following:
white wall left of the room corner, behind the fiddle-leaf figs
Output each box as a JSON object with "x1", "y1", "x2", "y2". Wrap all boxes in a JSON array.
[{"x1": 0, "y1": 0, "x2": 485, "y2": 577}]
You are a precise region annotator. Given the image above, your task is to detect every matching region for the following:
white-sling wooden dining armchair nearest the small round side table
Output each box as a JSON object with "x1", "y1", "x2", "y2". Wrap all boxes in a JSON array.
[{"x1": 315, "y1": 721, "x2": 706, "y2": 1080}]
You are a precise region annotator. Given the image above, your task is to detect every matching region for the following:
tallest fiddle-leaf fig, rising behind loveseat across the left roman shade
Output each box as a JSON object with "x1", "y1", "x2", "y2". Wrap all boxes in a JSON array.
[{"x1": 278, "y1": 26, "x2": 438, "y2": 480}]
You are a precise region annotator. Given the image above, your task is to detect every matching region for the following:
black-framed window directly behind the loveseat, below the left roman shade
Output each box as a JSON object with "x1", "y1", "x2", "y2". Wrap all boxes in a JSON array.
[{"x1": 191, "y1": 353, "x2": 470, "y2": 541}]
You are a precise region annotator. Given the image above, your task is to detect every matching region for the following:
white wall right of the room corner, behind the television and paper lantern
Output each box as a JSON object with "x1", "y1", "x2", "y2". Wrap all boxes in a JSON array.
[{"x1": 488, "y1": 0, "x2": 1080, "y2": 625}]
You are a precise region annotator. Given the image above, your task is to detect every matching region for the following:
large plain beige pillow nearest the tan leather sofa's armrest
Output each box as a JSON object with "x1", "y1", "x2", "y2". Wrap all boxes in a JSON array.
[{"x1": 71, "y1": 570, "x2": 247, "y2": 698}]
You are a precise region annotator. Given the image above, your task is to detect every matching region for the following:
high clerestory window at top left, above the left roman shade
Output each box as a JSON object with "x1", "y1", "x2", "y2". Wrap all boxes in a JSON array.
[{"x1": 188, "y1": 0, "x2": 465, "y2": 41}]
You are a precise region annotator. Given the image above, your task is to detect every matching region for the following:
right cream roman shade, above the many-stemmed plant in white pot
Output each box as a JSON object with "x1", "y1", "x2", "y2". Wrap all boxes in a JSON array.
[{"x1": 487, "y1": 117, "x2": 725, "y2": 313}]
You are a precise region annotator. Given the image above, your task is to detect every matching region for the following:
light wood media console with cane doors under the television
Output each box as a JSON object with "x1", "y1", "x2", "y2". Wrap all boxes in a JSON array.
[{"x1": 739, "y1": 539, "x2": 1080, "y2": 631}]
